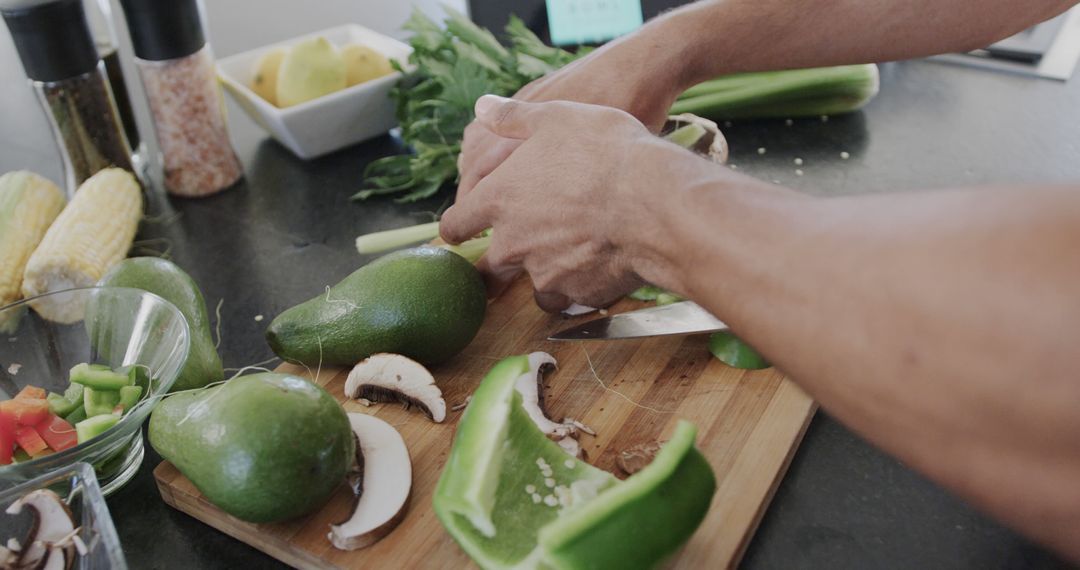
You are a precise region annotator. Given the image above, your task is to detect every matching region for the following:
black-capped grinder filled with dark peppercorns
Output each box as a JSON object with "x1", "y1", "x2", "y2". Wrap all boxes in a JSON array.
[{"x1": 0, "y1": 0, "x2": 132, "y2": 198}]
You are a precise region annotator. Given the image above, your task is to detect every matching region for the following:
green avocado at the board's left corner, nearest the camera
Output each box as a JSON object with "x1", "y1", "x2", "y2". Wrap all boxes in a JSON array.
[{"x1": 149, "y1": 372, "x2": 355, "y2": 523}]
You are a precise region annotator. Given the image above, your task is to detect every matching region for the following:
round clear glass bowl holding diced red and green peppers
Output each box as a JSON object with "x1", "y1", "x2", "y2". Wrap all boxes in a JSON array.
[{"x1": 0, "y1": 287, "x2": 189, "y2": 494}]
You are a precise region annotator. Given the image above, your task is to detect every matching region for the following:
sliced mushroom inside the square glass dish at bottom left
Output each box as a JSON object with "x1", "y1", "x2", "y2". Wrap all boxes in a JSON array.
[{"x1": 8, "y1": 489, "x2": 76, "y2": 570}]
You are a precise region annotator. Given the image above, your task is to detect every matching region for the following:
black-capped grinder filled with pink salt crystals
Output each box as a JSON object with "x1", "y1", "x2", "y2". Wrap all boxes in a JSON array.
[{"x1": 120, "y1": 0, "x2": 243, "y2": 196}]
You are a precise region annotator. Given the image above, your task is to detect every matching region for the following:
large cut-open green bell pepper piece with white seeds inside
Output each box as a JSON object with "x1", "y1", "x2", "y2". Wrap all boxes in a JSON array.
[{"x1": 434, "y1": 356, "x2": 716, "y2": 569}]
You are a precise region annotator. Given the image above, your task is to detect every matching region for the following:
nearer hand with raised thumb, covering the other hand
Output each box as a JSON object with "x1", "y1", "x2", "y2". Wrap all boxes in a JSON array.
[{"x1": 440, "y1": 95, "x2": 708, "y2": 311}]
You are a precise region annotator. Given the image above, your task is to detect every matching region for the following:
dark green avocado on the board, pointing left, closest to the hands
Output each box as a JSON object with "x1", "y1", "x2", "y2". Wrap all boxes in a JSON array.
[{"x1": 266, "y1": 246, "x2": 487, "y2": 366}]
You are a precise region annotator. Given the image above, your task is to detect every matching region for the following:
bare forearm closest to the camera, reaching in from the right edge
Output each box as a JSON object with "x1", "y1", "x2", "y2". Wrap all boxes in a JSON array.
[{"x1": 642, "y1": 168, "x2": 1080, "y2": 558}]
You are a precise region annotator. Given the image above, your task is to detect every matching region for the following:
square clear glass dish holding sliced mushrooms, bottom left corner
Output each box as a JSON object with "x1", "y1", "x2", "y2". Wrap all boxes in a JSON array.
[{"x1": 0, "y1": 462, "x2": 127, "y2": 570}]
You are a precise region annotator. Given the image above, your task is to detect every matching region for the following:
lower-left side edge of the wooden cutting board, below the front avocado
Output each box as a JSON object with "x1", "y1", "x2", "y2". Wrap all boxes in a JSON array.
[{"x1": 153, "y1": 461, "x2": 339, "y2": 570}]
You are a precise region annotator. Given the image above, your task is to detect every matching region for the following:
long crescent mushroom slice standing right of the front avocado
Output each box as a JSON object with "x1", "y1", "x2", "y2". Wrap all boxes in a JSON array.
[{"x1": 327, "y1": 413, "x2": 413, "y2": 551}]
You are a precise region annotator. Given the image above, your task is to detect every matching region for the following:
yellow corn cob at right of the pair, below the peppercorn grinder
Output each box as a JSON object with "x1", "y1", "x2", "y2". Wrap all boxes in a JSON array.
[{"x1": 23, "y1": 168, "x2": 143, "y2": 323}]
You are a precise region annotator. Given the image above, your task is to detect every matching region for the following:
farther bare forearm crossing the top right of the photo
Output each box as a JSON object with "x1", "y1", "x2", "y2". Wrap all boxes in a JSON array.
[{"x1": 630, "y1": 0, "x2": 1076, "y2": 89}]
